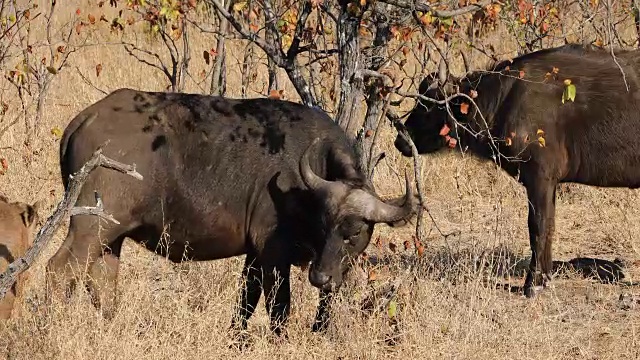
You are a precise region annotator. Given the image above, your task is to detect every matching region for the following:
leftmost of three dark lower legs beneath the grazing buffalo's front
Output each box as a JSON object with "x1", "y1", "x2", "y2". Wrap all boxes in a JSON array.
[{"x1": 231, "y1": 253, "x2": 262, "y2": 345}]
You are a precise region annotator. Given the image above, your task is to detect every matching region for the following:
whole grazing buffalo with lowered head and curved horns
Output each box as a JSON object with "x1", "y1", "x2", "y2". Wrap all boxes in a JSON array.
[{"x1": 47, "y1": 89, "x2": 417, "y2": 334}]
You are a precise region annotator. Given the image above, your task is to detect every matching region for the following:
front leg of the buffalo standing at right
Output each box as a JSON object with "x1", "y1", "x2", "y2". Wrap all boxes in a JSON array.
[{"x1": 524, "y1": 179, "x2": 556, "y2": 298}]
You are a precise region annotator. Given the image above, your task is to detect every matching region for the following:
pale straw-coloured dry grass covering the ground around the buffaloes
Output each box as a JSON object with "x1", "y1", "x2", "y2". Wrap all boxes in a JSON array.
[{"x1": 0, "y1": 1, "x2": 640, "y2": 359}]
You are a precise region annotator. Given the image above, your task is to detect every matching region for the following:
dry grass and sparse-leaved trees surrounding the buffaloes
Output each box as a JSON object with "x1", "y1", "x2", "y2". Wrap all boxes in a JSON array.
[{"x1": 0, "y1": 0, "x2": 640, "y2": 359}]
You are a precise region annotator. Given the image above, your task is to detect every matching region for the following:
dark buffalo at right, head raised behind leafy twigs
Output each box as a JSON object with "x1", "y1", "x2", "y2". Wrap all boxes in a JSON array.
[{"x1": 395, "y1": 44, "x2": 640, "y2": 297}]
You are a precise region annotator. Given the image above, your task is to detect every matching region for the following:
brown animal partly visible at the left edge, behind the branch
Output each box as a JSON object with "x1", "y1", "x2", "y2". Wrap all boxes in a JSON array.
[{"x1": 0, "y1": 195, "x2": 40, "y2": 319}]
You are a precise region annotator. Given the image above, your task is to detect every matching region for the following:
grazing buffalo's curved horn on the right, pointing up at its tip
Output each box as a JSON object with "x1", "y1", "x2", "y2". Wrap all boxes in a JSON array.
[{"x1": 358, "y1": 168, "x2": 415, "y2": 223}]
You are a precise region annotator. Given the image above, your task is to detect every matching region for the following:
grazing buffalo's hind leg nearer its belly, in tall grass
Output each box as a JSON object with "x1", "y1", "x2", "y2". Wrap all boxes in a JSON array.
[{"x1": 88, "y1": 236, "x2": 124, "y2": 319}]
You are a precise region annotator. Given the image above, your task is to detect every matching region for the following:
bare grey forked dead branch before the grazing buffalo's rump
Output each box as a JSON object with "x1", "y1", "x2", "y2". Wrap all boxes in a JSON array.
[{"x1": 0, "y1": 144, "x2": 143, "y2": 299}]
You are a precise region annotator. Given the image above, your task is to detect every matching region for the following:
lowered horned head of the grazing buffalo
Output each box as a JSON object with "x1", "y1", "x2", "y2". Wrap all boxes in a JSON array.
[{"x1": 300, "y1": 138, "x2": 417, "y2": 290}]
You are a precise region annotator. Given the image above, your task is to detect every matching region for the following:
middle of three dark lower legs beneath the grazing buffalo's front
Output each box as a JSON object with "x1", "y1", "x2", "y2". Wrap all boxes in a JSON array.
[{"x1": 262, "y1": 264, "x2": 291, "y2": 336}]
